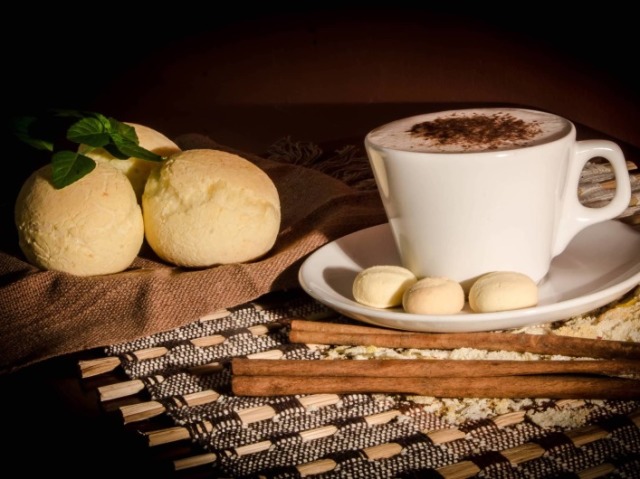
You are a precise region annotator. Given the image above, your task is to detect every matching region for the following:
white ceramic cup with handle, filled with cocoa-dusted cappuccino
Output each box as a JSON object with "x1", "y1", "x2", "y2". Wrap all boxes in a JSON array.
[{"x1": 365, "y1": 108, "x2": 631, "y2": 288}]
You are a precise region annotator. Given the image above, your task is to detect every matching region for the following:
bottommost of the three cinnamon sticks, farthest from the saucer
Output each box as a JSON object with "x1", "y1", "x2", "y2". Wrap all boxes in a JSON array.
[{"x1": 231, "y1": 375, "x2": 640, "y2": 399}]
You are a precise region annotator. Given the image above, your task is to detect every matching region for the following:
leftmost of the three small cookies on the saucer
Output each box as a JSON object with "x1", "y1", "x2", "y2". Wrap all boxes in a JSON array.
[{"x1": 353, "y1": 265, "x2": 418, "y2": 308}]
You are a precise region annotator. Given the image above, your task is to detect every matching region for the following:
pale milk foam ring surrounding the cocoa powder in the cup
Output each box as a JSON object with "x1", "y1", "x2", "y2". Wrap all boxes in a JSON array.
[{"x1": 367, "y1": 108, "x2": 571, "y2": 153}]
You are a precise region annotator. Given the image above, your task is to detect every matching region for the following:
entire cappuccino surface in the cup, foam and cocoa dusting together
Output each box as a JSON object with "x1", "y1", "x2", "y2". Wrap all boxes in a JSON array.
[{"x1": 368, "y1": 108, "x2": 571, "y2": 153}]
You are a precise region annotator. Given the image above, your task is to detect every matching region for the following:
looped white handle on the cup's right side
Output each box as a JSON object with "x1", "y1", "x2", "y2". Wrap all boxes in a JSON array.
[{"x1": 553, "y1": 140, "x2": 631, "y2": 256}]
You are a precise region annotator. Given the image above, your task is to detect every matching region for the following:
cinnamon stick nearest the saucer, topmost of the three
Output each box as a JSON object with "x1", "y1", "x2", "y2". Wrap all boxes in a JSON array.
[{"x1": 289, "y1": 320, "x2": 640, "y2": 359}]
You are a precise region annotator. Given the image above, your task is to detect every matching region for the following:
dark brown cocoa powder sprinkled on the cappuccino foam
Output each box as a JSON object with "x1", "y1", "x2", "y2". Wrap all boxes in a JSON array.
[{"x1": 409, "y1": 112, "x2": 542, "y2": 150}]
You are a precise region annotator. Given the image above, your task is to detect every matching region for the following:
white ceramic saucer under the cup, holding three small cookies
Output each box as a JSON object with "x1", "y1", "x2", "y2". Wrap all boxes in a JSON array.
[{"x1": 298, "y1": 220, "x2": 640, "y2": 333}]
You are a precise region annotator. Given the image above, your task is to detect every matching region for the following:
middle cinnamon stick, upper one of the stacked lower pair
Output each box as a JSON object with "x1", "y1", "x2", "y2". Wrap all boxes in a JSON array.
[{"x1": 231, "y1": 358, "x2": 640, "y2": 378}]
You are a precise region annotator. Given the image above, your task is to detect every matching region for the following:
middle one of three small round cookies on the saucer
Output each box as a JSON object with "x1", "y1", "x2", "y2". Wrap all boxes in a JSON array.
[{"x1": 402, "y1": 276, "x2": 464, "y2": 314}]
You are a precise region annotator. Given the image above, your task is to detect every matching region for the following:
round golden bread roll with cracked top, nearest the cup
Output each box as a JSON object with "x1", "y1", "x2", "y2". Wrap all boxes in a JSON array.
[{"x1": 142, "y1": 149, "x2": 280, "y2": 267}]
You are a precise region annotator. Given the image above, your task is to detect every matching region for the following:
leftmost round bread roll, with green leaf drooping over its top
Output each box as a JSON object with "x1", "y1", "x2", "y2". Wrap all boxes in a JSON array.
[{"x1": 15, "y1": 163, "x2": 144, "y2": 276}]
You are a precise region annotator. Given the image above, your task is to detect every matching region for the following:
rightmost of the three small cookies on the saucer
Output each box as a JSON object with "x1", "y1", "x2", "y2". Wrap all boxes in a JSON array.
[{"x1": 469, "y1": 271, "x2": 538, "y2": 313}]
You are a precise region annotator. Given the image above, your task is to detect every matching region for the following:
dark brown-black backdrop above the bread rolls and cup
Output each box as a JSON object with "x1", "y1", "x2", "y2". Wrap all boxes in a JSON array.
[{"x1": 3, "y1": 2, "x2": 640, "y2": 143}]
